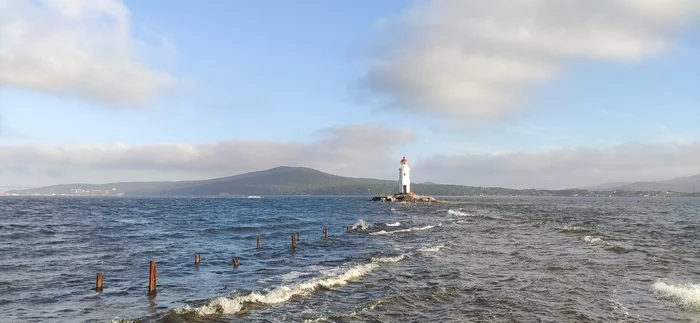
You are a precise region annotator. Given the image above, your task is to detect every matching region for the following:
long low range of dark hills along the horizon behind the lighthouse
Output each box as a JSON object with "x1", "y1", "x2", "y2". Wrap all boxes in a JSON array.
[{"x1": 7, "y1": 166, "x2": 693, "y2": 196}]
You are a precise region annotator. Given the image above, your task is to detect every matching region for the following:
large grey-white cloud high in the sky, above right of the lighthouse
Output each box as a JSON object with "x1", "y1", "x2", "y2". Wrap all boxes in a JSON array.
[{"x1": 360, "y1": 0, "x2": 700, "y2": 117}]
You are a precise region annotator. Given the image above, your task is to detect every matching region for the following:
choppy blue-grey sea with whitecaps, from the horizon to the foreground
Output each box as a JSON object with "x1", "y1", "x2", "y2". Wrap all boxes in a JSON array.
[{"x1": 0, "y1": 196, "x2": 700, "y2": 322}]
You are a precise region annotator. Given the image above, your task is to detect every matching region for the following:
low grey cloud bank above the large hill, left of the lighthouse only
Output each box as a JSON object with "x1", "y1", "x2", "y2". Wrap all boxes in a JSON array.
[{"x1": 0, "y1": 125, "x2": 413, "y2": 185}]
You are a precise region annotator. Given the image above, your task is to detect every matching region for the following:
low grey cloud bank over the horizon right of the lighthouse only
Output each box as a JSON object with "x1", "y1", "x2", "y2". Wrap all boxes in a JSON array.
[{"x1": 413, "y1": 141, "x2": 700, "y2": 189}]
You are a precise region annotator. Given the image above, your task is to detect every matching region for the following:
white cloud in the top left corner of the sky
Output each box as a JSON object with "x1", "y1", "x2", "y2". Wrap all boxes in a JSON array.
[{"x1": 0, "y1": 0, "x2": 176, "y2": 105}]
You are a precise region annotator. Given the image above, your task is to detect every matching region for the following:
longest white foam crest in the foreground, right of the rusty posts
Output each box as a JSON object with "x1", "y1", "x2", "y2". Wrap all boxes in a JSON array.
[{"x1": 174, "y1": 264, "x2": 382, "y2": 316}]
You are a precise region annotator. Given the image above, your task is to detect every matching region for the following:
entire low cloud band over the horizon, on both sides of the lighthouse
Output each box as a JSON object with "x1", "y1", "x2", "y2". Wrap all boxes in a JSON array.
[{"x1": 0, "y1": 130, "x2": 700, "y2": 189}]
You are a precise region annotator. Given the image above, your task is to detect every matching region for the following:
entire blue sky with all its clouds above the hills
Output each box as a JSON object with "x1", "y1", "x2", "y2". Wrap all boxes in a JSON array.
[{"x1": 0, "y1": 0, "x2": 700, "y2": 190}]
